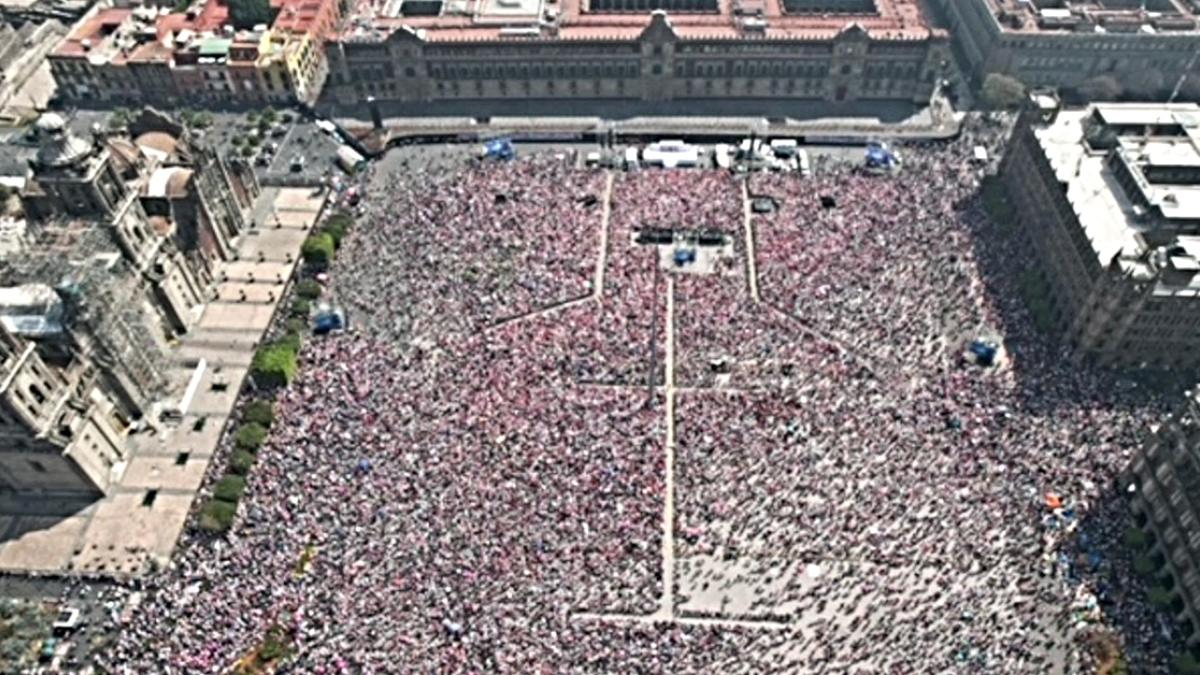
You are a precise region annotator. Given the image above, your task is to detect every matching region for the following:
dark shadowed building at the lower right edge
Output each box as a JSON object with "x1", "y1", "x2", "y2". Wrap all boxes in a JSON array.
[{"x1": 1123, "y1": 390, "x2": 1200, "y2": 640}]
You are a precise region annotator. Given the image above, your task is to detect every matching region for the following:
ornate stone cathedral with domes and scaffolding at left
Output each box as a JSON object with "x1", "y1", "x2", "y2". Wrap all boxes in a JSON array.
[{"x1": 0, "y1": 109, "x2": 258, "y2": 495}]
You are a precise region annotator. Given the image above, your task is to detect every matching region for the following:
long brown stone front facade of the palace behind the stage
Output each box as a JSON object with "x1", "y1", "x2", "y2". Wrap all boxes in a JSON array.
[{"x1": 323, "y1": 12, "x2": 949, "y2": 104}]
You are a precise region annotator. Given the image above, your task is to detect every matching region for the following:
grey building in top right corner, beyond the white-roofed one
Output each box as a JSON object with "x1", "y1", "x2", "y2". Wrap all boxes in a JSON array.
[{"x1": 931, "y1": 0, "x2": 1200, "y2": 97}]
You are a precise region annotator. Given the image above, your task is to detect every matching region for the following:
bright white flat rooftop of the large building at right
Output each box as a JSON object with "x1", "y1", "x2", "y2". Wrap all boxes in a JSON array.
[{"x1": 1034, "y1": 103, "x2": 1200, "y2": 295}]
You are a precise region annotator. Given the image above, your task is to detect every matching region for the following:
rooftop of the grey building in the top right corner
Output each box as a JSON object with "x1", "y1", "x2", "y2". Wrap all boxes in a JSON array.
[{"x1": 984, "y1": 0, "x2": 1198, "y2": 35}]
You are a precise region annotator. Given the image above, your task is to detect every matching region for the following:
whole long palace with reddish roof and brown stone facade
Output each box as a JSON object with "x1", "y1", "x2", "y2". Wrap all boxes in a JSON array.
[{"x1": 323, "y1": 0, "x2": 949, "y2": 104}]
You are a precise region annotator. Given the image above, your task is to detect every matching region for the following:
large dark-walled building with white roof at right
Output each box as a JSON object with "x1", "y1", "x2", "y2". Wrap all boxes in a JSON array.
[{"x1": 1001, "y1": 103, "x2": 1200, "y2": 368}]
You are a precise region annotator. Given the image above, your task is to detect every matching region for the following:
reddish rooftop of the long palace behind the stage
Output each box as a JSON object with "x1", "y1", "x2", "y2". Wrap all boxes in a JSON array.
[{"x1": 341, "y1": 0, "x2": 946, "y2": 42}]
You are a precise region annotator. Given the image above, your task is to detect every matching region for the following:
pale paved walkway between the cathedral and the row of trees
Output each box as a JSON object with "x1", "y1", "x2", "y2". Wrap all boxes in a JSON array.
[{"x1": 0, "y1": 189, "x2": 326, "y2": 577}]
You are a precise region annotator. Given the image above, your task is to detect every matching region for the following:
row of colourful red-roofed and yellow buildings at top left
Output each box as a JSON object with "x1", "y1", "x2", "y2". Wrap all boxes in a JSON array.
[{"x1": 48, "y1": 0, "x2": 341, "y2": 106}]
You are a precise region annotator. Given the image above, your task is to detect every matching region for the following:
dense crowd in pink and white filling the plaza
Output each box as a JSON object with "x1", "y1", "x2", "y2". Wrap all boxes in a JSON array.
[{"x1": 106, "y1": 118, "x2": 1190, "y2": 674}]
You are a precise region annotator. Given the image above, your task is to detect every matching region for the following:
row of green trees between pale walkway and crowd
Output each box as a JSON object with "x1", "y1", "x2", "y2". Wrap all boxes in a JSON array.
[{"x1": 197, "y1": 207, "x2": 354, "y2": 534}]
